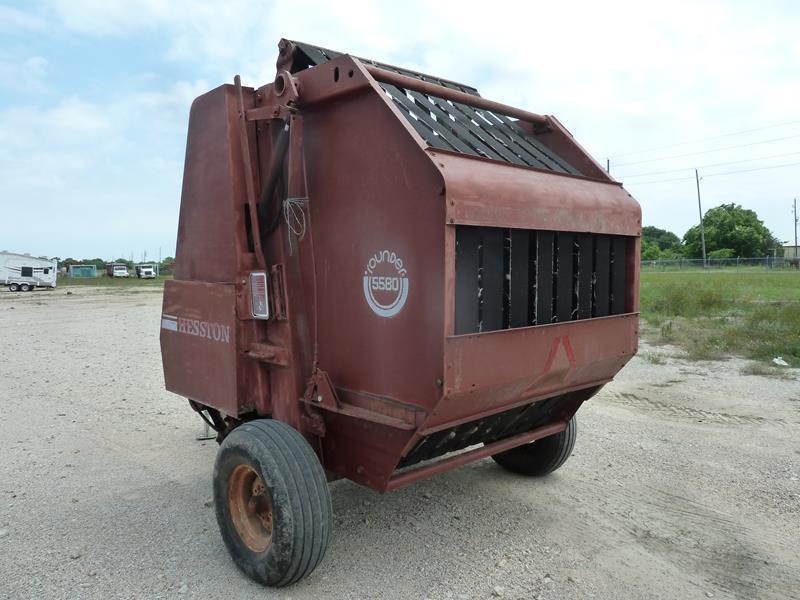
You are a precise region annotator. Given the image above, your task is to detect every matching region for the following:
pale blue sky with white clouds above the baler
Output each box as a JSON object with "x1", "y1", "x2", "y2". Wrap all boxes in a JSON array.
[{"x1": 0, "y1": 0, "x2": 800, "y2": 260}]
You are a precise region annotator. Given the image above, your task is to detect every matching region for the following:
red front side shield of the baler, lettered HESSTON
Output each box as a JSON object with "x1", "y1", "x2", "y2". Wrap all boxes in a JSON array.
[{"x1": 167, "y1": 85, "x2": 271, "y2": 415}]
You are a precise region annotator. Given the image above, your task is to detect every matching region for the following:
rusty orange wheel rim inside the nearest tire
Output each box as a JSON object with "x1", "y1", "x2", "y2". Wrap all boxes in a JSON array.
[{"x1": 228, "y1": 464, "x2": 272, "y2": 552}]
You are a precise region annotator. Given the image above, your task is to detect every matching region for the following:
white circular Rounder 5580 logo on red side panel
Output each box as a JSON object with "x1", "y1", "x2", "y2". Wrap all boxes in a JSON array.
[{"x1": 364, "y1": 250, "x2": 408, "y2": 317}]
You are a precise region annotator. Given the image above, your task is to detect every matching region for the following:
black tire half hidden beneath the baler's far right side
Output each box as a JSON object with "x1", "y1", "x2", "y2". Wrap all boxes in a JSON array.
[{"x1": 492, "y1": 417, "x2": 578, "y2": 477}]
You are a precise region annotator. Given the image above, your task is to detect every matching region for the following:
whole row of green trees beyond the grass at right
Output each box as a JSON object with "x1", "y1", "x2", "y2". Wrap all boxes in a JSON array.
[{"x1": 642, "y1": 204, "x2": 782, "y2": 260}]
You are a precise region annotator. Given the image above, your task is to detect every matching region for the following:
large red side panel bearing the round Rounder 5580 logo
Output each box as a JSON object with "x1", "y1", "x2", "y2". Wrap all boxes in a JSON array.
[{"x1": 300, "y1": 91, "x2": 445, "y2": 418}]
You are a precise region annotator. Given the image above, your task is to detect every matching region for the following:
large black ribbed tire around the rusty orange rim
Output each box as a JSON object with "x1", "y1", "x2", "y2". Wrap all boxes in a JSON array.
[{"x1": 214, "y1": 419, "x2": 333, "y2": 587}]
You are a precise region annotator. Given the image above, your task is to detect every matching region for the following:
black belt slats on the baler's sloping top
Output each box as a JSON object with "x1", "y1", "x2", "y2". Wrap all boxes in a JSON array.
[{"x1": 293, "y1": 42, "x2": 579, "y2": 174}]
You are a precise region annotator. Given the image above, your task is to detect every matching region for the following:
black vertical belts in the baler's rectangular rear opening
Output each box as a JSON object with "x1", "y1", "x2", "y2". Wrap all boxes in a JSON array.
[{"x1": 455, "y1": 225, "x2": 632, "y2": 335}]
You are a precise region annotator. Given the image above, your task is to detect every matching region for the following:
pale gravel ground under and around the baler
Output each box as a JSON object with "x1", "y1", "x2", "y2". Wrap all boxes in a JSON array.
[{"x1": 0, "y1": 287, "x2": 800, "y2": 600}]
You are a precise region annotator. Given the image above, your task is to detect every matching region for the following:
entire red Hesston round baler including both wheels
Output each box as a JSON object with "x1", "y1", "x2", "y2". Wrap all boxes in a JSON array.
[{"x1": 161, "y1": 40, "x2": 641, "y2": 586}]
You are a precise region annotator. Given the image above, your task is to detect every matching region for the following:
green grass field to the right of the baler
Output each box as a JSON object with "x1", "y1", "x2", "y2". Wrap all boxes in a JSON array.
[{"x1": 641, "y1": 271, "x2": 800, "y2": 367}]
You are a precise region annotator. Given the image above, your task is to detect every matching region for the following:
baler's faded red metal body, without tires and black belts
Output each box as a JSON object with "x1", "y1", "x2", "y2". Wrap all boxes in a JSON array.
[{"x1": 162, "y1": 41, "x2": 641, "y2": 491}]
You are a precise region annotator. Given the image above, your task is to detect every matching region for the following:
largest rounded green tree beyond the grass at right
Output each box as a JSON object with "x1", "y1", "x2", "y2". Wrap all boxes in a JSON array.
[{"x1": 683, "y1": 204, "x2": 780, "y2": 258}]
